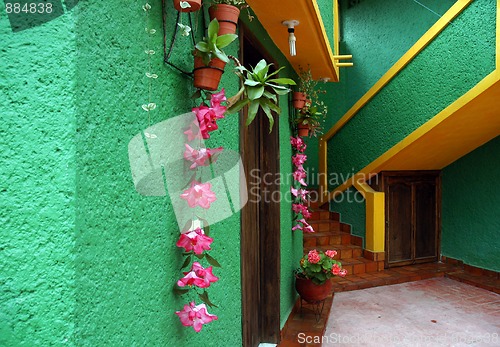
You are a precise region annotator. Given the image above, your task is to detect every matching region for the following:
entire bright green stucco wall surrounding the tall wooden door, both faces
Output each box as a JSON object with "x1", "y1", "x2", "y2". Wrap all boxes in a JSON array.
[{"x1": 0, "y1": 0, "x2": 302, "y2": 346}]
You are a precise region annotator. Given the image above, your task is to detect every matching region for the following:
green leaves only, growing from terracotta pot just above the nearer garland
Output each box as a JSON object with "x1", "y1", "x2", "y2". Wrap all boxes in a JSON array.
[{"x1": 195, "y1": 19, "x2": 238, "y2": 65}]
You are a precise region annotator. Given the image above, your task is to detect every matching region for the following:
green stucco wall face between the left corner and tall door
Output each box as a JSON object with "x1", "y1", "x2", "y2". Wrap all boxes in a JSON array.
[{"x1": 75, "y1": 0, "x2": 241, "y2": 346}]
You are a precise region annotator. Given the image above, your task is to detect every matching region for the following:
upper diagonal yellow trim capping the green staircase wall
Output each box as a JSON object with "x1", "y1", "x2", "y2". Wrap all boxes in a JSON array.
[{"x1": 319, "y1": 0, "x2": 472, "y2": 190}]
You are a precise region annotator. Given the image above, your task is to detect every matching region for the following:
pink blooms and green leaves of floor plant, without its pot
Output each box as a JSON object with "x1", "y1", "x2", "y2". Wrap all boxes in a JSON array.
[{"x1": 295, "y1": 249, "x2": 347, "y2": 285}]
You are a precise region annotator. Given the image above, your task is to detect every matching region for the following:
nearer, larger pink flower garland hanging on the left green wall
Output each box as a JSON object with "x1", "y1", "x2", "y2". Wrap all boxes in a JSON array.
[{"x1": 175, "y1": 89, "x2": 226, "y2": 332}]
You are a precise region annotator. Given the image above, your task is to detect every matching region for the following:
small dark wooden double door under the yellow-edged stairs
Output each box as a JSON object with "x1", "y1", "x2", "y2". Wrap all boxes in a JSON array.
[{"x1": 382, "y1": 171, "x2": 440, "y2": 267}]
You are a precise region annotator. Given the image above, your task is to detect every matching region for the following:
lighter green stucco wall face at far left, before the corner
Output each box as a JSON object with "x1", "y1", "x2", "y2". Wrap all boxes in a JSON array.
[{"x1": 0, "y1": 8, "x2": 75, "y2": 347}]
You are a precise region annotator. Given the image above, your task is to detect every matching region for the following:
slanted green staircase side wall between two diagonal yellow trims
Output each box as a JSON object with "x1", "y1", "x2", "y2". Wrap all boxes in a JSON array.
[{"x1": 328, "y1": 0, "x2": 496, "y2": 182}]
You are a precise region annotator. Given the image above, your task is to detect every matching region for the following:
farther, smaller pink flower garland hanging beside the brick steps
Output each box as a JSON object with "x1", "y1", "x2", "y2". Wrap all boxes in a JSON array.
[{"x1": 290, "y1": 136, "x2": 314, "y2": 233}]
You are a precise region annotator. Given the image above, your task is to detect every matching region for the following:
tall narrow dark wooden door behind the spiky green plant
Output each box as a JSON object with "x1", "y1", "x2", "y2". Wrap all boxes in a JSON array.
[{"x1": 240, "y1": 28, "x2": 280, "y2": 347}]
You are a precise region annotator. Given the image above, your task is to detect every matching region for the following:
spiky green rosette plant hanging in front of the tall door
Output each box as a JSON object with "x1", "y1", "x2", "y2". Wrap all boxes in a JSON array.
[{"x1": 227, "y1": 59, "x2": 296, "y2": 132}]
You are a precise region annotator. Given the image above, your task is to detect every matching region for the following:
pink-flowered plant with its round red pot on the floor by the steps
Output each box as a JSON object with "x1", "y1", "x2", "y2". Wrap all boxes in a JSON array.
[{"x1": 295, "y1": 249, "x2": 347, "y2": 303}]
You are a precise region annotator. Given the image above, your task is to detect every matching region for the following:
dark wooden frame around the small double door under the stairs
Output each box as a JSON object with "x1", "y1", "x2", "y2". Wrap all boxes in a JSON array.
[{"x1": 377, "y1": 170, "x2": 441, "y2": 268}]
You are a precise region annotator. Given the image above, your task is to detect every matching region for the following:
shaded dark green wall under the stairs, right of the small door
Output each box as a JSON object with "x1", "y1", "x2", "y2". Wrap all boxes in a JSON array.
[{"x1": 441, "y1": 137, "x2": 500, "y2": 271}]
